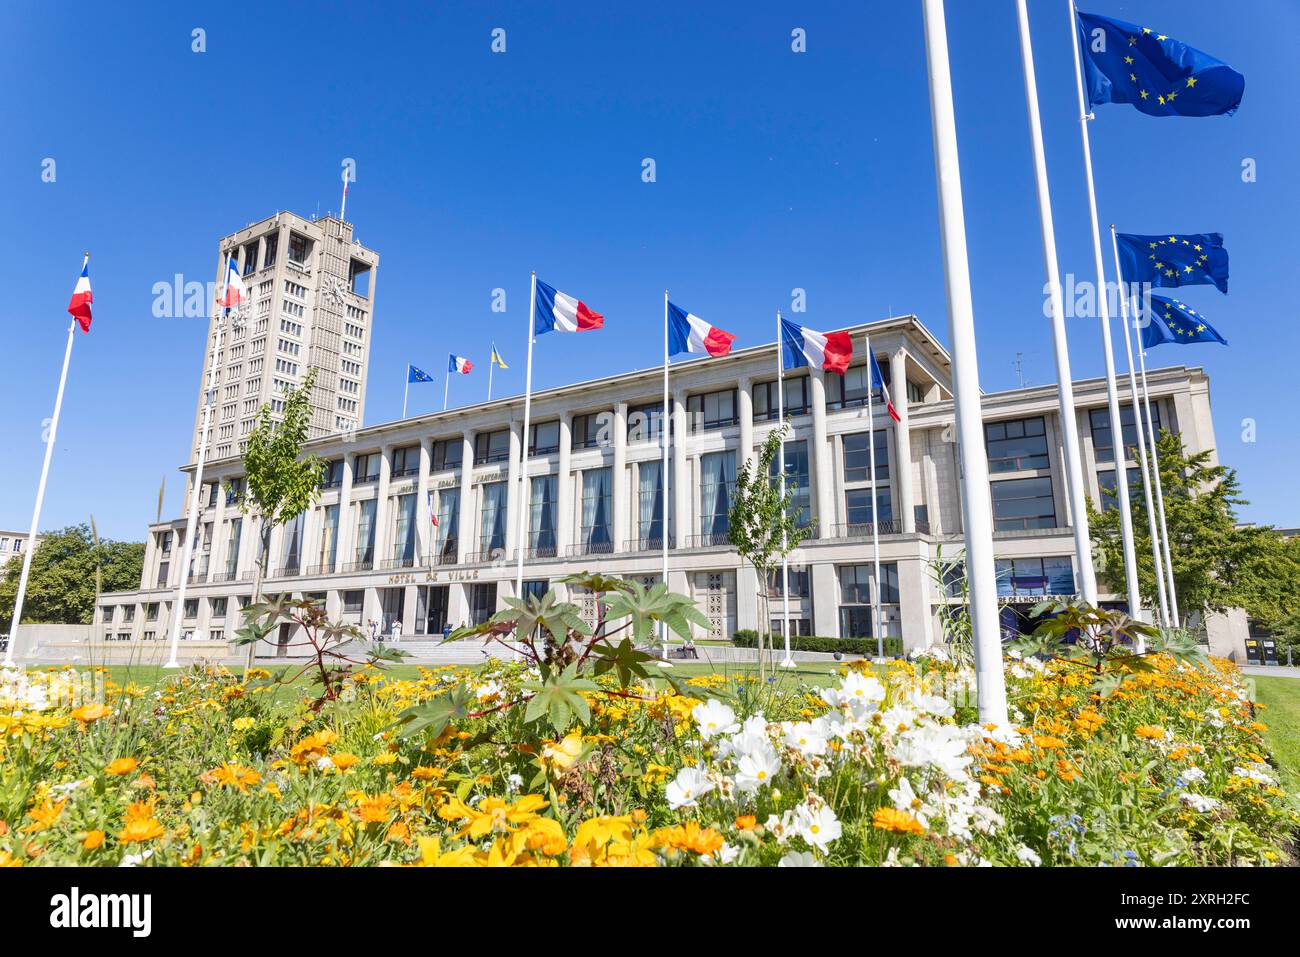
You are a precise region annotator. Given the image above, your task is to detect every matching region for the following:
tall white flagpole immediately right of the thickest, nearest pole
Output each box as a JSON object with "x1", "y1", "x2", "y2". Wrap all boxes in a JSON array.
[{"x1": 1015, "y1": 0, "x2": 1097, "y2": 605}]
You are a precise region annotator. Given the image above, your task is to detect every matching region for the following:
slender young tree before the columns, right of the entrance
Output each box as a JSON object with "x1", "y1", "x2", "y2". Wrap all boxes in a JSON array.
[{"x1": 727, "y1": 423, "x2": 813, "y2": 679}]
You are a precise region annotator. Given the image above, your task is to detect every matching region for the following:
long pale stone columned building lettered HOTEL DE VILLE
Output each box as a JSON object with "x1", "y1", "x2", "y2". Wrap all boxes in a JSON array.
[{"x1": 95, "y1": 314, "x2": 1245, "y2": 661}]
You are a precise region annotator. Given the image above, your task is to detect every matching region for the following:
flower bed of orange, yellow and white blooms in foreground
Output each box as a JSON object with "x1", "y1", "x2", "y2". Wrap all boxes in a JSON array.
[{"x1": 0, "y1": 655, "x2": 1300, "y2": 866}]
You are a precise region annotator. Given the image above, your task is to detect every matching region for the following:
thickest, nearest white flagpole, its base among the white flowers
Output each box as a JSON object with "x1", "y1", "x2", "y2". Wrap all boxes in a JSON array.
[{"x1": 920, "y1": 0, "x2": 1008, "y2": 724}]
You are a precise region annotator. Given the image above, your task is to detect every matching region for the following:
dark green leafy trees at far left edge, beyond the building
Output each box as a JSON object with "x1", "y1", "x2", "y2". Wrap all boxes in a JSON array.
[{"x1": 0, "y1": 524, "x2": 144, "y2": 631}]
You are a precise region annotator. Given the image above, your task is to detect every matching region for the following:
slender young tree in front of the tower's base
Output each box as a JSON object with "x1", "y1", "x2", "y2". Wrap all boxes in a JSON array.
[{"x1": 239, "y1": 369, "x2": 325, "y2": 667}]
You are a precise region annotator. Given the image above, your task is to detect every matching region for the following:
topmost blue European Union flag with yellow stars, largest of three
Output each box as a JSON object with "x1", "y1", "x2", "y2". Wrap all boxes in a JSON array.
[{"x1": 1078, "y1": 13, "x2": 1245, "y2": 116}]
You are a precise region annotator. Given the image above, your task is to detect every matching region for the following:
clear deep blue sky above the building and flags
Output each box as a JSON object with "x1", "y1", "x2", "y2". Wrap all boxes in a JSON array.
[{"x1": 0, "y1": 0, "x2": 1300, "y2": 540}]
